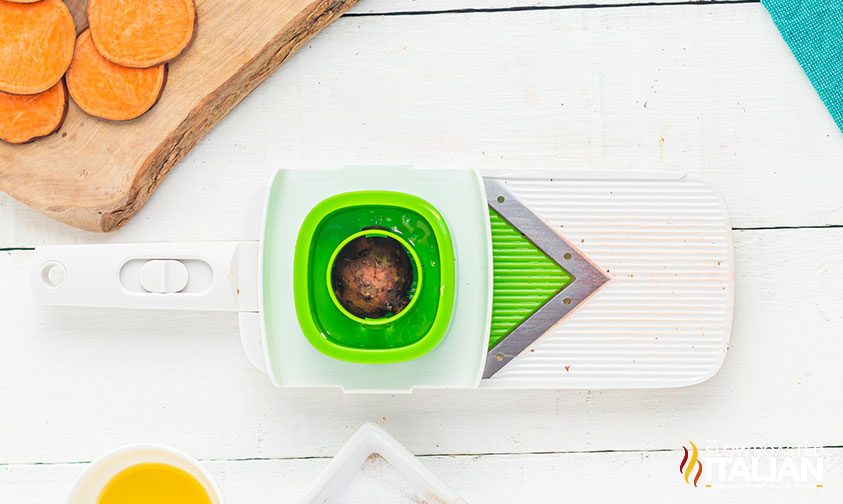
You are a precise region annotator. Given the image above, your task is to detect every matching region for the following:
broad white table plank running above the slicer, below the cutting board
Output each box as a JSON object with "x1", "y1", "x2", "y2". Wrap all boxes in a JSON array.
[{"x1": 0, "y1": 2, "x2": 843, "y2": 247}]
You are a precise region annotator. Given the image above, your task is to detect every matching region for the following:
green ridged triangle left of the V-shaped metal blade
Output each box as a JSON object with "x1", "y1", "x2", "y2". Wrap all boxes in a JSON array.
[{"x1": 489, "y1": 208, "x2": 572, "y2": 348}]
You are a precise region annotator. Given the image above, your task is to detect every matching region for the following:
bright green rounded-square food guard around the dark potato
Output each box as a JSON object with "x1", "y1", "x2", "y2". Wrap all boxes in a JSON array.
[{"x1": 293, "y1": 191, "x2": 456, "y2": 364}]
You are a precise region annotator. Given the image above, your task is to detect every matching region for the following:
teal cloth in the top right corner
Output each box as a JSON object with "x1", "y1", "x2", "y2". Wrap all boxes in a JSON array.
[{"x1": 761, "y1": 0, "x2": 843, "y2": 131}]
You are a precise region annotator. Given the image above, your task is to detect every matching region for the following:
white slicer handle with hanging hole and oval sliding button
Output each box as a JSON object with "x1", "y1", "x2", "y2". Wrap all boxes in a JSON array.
[{"x1": 31, "y1": 241, "x2": 258, "y2": 311}]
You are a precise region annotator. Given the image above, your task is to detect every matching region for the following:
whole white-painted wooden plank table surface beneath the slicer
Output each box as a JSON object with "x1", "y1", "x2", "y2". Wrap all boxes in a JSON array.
[{"x1": 0, "y1": 0, "x2": 843, "y2": 504}]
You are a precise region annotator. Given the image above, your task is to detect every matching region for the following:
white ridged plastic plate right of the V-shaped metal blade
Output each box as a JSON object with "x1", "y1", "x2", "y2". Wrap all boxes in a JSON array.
[{"x1": 483, "y1": 172, "x2": 734, "y2": 388}]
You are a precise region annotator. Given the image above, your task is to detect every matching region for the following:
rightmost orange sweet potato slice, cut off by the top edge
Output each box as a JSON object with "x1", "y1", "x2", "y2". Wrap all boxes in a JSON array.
[{"x1": 88, "y1": 0, "x2": 196, "y2": 68}]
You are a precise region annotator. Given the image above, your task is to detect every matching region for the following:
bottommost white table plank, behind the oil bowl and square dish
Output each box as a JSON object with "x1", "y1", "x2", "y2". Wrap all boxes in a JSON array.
[{"x1": 0, "y1": 449, "x2": 843, "y2": 504}]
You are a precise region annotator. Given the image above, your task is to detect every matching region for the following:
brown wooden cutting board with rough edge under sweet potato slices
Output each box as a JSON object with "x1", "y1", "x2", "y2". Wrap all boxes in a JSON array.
[{"x1": 0, "y1": 0, "x2": 357, "y2": 231}]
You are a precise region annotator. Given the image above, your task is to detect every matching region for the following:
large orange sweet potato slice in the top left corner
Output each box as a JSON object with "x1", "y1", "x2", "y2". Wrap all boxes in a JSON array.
[{"x1": 0, "y1": 0, "x2": 76, "y2": 94}]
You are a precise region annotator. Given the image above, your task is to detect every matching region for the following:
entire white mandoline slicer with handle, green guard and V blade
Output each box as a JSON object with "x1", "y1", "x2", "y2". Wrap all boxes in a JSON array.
[{"x1": 32, "y1": 166, "x2": 734, "y2": 392}]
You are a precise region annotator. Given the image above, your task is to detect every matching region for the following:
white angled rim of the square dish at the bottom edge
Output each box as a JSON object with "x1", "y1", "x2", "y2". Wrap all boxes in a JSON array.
[{"x1": 301, "y1": 423, "x2": 466, "y2": 504}]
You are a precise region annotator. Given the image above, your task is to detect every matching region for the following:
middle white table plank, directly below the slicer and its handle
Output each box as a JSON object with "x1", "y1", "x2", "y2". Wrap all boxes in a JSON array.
[{"x1": 0, "y1": 229, "x2": 843, "y2": 463}]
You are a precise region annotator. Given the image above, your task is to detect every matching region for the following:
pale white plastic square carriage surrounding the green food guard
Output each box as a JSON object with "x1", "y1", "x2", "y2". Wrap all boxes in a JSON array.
[{"x1": 258, "y1": 165, "x2": 492, "y2": 393}]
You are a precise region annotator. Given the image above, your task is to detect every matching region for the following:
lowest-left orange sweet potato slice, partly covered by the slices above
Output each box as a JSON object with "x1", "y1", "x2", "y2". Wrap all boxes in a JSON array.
[{"x1": 0, "y1": 81, "x2": 67, "y2": 144}]
